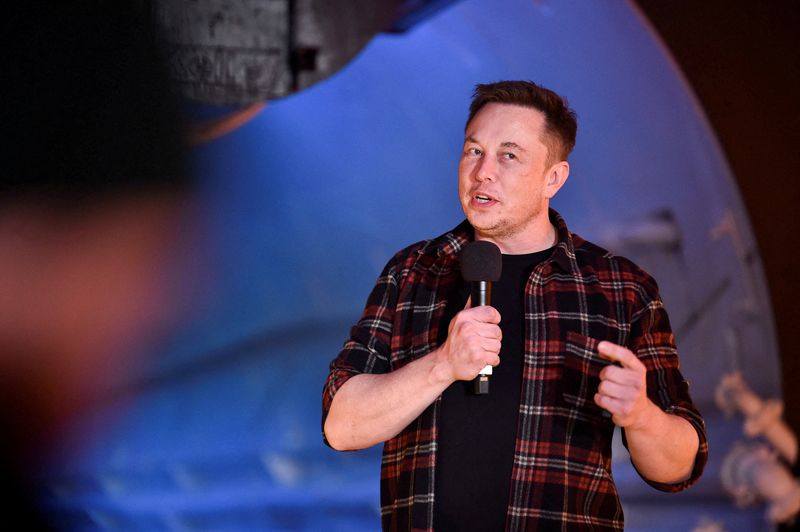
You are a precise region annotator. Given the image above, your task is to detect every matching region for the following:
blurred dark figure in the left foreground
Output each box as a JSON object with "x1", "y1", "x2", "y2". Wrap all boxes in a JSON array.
[{"x1": 0, "y1": 0, "x2": 190, "y2": 529}]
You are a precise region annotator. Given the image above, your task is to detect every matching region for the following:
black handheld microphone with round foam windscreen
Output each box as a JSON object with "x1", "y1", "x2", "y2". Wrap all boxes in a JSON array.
[{"x1": 461, "y1": 240, "x2": 503, "y2": 395}]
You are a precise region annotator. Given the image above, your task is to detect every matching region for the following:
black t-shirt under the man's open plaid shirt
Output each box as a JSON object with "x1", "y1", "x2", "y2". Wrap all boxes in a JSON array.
[{"x1": 433, "y1": 248, "x2": 552, "y2": 532}]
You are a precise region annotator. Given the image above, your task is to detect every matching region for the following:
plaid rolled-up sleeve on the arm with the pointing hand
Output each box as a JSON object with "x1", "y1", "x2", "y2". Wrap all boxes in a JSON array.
[{"x1": 622, "y1": 276, "x2": 708, "y2": 492}]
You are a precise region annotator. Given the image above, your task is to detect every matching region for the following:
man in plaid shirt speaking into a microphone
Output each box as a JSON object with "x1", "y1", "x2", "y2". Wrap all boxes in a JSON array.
[{"x1": 323, "y1": 81, "x2": 708, "y2": 531}]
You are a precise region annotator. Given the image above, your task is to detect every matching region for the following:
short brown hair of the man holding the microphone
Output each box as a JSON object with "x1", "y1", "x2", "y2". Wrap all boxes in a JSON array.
[{"x1": 464, "y1": 81, "x2": 578, "y2": 164}]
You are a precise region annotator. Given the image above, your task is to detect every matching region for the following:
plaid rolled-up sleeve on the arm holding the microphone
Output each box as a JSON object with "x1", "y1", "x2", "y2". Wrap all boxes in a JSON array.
[{"x1": 322, "y1": 259, "x2": 397, "y2": 445}]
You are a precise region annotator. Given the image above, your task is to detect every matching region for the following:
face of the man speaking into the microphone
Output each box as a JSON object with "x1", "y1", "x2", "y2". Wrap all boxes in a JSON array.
[{"x1": 458, "y1": 103, "x2": 557, "y2": 249}]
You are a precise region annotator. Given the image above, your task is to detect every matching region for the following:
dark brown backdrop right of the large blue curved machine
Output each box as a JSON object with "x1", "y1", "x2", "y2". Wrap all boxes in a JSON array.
[{"x1": 636, "y1": 0, "x2": 800, "y2": 434}]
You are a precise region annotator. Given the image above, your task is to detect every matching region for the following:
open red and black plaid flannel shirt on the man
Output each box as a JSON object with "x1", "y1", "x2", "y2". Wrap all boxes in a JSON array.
[{"x1": 323, "y1": 209, "x2": 708, "y2": 530}]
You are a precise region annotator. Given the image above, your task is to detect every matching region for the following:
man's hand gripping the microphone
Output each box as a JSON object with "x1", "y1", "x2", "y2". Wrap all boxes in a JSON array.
[{"x1": 438, "y1": 302, "x2": 503, "y2": 381}]
